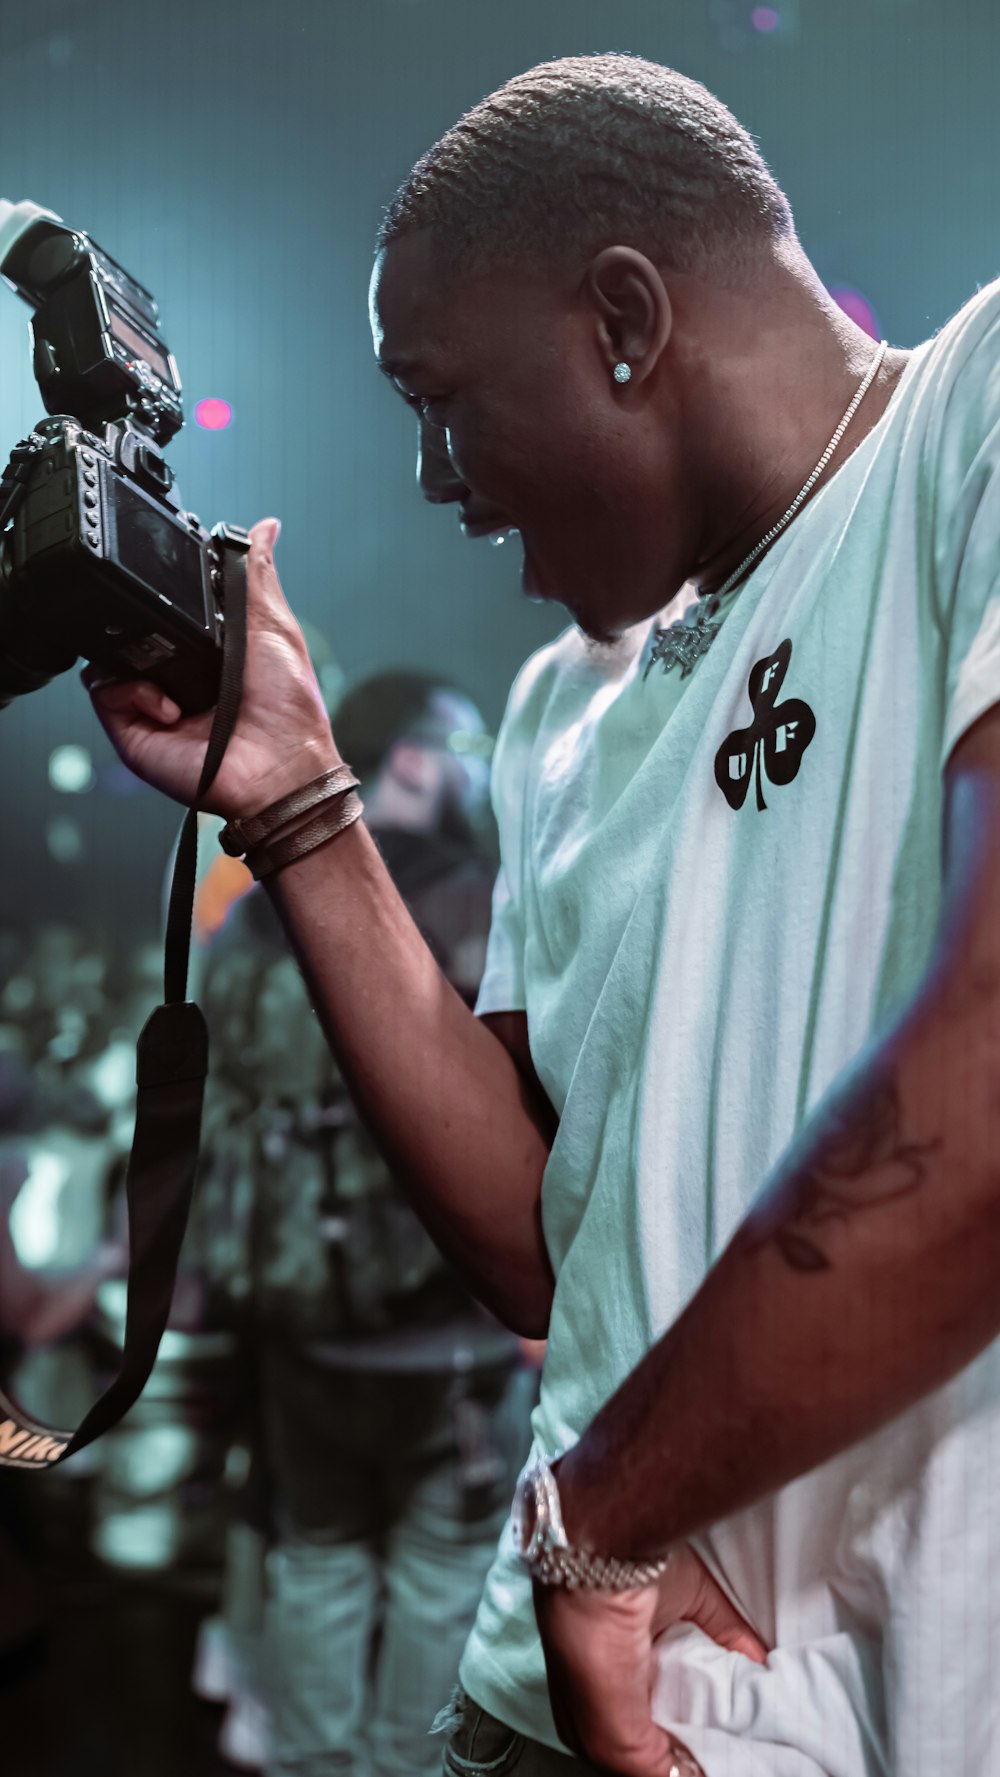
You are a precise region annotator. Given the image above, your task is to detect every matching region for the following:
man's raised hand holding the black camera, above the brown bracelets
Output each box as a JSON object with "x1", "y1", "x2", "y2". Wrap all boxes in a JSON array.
[{"x1": 83, "y1": 519, "x2": 339, "y2": 819}]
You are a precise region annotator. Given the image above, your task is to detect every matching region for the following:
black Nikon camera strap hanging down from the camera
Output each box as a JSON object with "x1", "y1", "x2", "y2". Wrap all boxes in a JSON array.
[{"x1": 0, "y1": 524, "x2": 250, "y2": 1470}]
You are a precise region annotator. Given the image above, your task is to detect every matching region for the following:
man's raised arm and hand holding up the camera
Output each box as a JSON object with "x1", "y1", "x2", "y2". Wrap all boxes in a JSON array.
[{"x1": 83, "y1": 521, "x2": 554, "y2": 1336}]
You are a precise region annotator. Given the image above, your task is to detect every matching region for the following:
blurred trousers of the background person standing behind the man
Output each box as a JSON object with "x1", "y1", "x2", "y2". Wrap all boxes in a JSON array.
[{"x1": 263, "y1": 1352, "x2": 533, "y2": 1777}]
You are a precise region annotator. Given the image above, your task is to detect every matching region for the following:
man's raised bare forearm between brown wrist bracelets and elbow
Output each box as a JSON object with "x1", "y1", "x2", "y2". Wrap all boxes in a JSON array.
[{"x1": 270, "y1": 823, "x2": 552, "y2": 1336}]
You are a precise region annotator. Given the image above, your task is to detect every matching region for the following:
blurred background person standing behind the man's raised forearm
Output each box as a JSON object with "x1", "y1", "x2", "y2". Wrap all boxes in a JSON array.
[{"x1": 188, "y1": 672, "x2": 533, "y2": 1777}]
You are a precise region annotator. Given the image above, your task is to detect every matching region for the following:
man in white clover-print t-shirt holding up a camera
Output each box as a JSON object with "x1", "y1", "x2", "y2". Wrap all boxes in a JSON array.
[{"x1": 83, "y1": 57, "x2": 1000, "y2": 1777}]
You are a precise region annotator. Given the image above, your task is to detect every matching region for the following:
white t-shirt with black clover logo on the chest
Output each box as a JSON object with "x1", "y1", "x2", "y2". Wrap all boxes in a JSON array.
[{"x1": 462, "y1": 284, "x2": 1000, "y2": 1777}]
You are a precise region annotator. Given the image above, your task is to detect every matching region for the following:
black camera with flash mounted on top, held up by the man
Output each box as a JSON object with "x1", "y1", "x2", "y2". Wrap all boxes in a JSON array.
[{"x1": 0, "y1": 199, "x2": 247, "y2": 714}]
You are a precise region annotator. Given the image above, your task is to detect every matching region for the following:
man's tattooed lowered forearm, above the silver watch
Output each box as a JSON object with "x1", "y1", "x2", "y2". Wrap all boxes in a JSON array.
[{"x1": 560, "y1": 1000, "x2": 1000, "y2": 1557}]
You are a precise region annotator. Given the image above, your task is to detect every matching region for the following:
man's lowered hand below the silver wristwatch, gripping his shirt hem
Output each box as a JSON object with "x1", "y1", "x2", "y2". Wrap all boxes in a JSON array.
[{"x1": 535, "y1": 1542, "x2": 767, "y2": 1777}]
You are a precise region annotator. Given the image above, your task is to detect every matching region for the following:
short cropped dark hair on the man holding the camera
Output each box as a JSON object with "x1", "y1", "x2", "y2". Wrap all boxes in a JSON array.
[{"x1": 378, "y1": 55, "x2": 794, "y2": 281}]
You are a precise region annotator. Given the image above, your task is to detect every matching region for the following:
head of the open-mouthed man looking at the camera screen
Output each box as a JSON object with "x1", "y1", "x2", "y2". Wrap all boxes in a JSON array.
[{"x1": 371, "y1": 55, "x2": 820, "y2": 638}]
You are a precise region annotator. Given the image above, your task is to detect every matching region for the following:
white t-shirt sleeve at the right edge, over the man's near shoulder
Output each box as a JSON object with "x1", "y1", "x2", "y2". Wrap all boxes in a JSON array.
[{"x1": 933, "y1": 286, "x2": 1000, "y2": 766}]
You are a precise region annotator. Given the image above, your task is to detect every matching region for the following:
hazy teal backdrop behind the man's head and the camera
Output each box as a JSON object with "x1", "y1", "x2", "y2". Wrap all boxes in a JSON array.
[{"x1": 0, "y1": 0, "x2": 1000, "y2": 933}]
